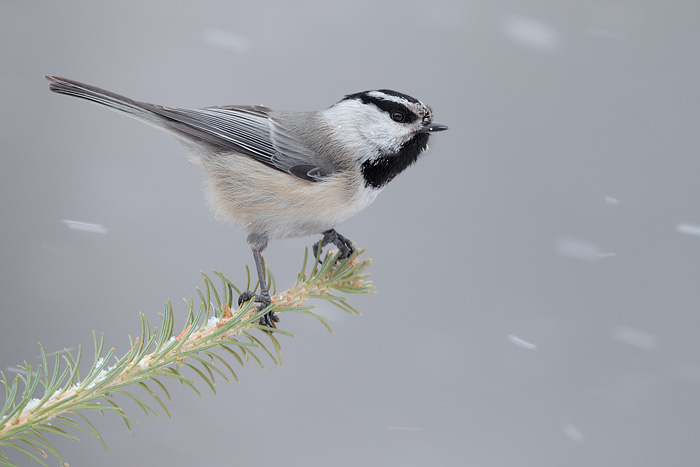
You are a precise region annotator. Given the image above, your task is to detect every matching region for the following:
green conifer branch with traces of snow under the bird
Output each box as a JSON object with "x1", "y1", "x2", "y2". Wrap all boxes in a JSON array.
[{"x1": 0, "y1": 250, "x2": 374, "y2": 467}]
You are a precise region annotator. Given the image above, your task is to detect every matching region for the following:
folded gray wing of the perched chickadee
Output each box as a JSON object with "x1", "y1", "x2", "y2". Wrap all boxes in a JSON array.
[{"x1": 138, "y1": 102, "x2": 333, "y2": 182}]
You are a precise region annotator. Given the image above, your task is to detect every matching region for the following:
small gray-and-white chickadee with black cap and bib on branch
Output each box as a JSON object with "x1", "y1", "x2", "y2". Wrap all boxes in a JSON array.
[{"x1": 46, "y1": 76, "x2": 447, "y2": 328}]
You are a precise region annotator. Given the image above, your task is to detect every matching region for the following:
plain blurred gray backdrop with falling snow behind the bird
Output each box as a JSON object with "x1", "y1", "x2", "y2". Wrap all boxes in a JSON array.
[{"x1": 0, "y1": 0, "x2": 700, "y2": 466}]
